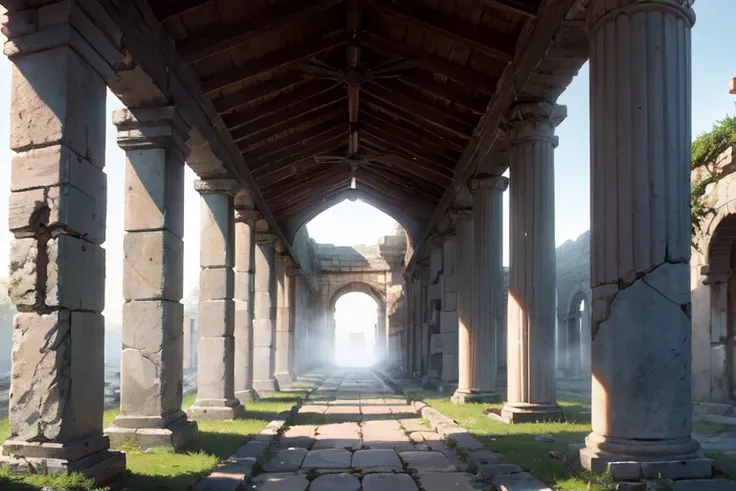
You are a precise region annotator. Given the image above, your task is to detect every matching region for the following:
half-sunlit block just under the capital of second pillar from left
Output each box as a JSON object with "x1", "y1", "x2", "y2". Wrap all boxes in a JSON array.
[{"x1": 125, "y1": 148, "x2": 184, "y2": 237}]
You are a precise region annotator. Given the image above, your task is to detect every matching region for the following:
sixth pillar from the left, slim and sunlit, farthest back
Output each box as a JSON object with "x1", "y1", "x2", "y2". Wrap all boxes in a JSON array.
[{"x1": 274, "y1": 250, "x2": 299, "y2": 390}]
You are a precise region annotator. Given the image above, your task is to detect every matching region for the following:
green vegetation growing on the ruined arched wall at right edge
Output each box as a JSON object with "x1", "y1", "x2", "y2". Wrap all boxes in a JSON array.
[{"x1": 690, "y1": 112, "x2": 736, "y2": 245}]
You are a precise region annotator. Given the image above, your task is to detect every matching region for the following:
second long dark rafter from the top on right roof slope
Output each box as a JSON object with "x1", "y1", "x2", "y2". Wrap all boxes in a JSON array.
[{"x1": 361, "y1": 32, "x2": 496, "y2": 94}]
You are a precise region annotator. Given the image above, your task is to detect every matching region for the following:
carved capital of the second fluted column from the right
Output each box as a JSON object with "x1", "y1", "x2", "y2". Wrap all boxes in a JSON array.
[{"x1": 508, "y1": 101, "x2": 567, "y2": 146}]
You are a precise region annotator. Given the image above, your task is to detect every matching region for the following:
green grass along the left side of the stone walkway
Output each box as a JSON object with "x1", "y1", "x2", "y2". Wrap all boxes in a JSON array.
[{"x1": 0, "y1": 391, "x2": 306, "y2": 491}]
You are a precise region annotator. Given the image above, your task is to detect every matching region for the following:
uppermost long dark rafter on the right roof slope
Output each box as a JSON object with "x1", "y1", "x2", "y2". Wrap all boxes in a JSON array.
[{"x1": 374, "y1": 0, "x2": 516, "y2": 61}]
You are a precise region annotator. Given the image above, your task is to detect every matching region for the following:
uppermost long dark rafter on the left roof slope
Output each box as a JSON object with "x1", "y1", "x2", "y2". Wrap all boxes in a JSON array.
[{"x1": 177, "y1": 0, "x2": 344, "y2": 63}]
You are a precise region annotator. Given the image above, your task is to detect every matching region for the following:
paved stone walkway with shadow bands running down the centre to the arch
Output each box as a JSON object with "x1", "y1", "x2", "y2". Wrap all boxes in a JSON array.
[{"x1": 248, "y1": 369, "x2": 489, "y2": 491}]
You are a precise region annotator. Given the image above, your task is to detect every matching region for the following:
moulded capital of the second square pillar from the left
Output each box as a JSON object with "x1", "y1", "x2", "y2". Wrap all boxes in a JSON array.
[{"x1": 112, "y1": 106, "x2": 190, "y2": 158}]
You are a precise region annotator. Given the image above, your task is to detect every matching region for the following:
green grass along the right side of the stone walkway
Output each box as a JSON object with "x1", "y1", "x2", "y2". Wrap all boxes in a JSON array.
[{"x1": 412, "y1": 391, "x2": 616, "y2": 491}]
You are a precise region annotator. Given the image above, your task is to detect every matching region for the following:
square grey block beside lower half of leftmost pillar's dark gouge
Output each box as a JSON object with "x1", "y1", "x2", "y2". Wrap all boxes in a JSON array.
[{"x1": 46, "y1": 235, "x2": 105, "y2": 312}]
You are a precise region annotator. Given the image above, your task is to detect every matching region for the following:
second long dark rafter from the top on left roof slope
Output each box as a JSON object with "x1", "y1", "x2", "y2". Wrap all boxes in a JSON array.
[{"x1": 202, "y1": 31, "x2": 347, "y2": 95}]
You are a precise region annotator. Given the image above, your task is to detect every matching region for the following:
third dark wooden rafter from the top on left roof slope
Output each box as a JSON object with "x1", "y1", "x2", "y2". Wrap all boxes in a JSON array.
[{"x1": 222, "y1": 80, "x2": 345, "y2": 130}]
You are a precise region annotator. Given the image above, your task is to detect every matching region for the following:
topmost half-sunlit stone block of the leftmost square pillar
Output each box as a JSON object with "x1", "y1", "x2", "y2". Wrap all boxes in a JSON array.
[{"x1": 10, "y1": 46, "x2": 107, "y2": 162}]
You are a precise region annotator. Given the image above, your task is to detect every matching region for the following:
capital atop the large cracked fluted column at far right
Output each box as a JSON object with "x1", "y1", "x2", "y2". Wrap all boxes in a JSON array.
[{"x1": 585, "y1": 0, "x2": 695, "y2": 36}]
